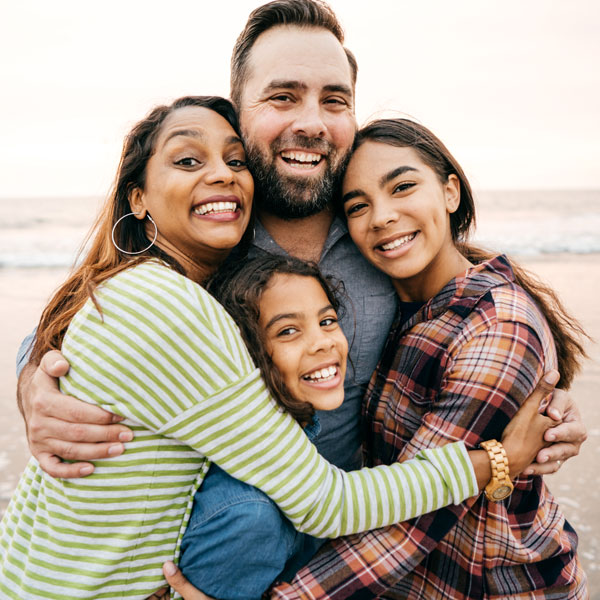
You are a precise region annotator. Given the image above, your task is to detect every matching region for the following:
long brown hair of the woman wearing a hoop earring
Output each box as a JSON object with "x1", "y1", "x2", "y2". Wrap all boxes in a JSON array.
[{"x1": 31, "y1": 96, "x2": 240, "y2": 364}]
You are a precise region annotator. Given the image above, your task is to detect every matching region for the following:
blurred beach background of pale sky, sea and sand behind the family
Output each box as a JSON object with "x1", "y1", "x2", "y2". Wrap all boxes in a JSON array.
[{"x1": 0, "y1": 0, "x2": 600, "y2": 598}]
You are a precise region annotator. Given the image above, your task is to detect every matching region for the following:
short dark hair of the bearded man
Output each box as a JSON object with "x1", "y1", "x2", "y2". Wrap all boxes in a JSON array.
[{"x1": 231, "y1": 0, "x2": 358, "y2": 109}]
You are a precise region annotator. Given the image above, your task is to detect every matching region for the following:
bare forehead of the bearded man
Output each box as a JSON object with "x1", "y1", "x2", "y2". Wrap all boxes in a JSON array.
[{"x1": 244, "y1": 25, "x2": 352, "y2": 96}]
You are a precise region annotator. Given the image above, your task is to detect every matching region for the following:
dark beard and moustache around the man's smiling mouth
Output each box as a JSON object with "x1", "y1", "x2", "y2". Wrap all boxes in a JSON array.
[{"x1": 246, "y1": 136, "x2": 350, "y2": 220}]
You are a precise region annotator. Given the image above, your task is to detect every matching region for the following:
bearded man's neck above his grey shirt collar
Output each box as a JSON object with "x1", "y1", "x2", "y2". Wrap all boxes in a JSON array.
[{"x1": 258, "y1": 208, "x2": 334, "y2": 262}]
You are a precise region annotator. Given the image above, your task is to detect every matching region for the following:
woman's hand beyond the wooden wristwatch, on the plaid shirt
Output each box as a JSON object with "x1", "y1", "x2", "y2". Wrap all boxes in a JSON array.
[{"x1": 502, "y1": 371, "x2": 559, "y2": 479}]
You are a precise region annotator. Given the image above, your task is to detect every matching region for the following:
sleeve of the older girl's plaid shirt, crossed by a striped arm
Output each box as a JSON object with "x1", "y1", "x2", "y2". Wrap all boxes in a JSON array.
[{"x1": 272, "y1": 322, "x2": 543, "y2": 600}]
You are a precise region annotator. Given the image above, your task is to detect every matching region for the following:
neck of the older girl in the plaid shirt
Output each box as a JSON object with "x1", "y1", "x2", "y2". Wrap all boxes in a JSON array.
[{"x1": 392, "y1": 244, "x2": 473, "y2": 302}]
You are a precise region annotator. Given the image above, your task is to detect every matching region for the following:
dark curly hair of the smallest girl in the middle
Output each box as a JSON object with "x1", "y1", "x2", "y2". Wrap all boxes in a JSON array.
[{"x1": 206, "y1": 255, "x2": 340, "y2": 423}]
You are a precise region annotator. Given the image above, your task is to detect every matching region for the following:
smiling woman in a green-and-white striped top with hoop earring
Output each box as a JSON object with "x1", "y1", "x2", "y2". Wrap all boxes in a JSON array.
[{"x1": 0, "y1": 97, "x2": 540, "y2": 598}]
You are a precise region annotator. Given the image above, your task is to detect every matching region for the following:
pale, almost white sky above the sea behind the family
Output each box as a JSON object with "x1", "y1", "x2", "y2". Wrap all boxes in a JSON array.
[{"x1": 0, "y1": 0, "x2": 600, "y2": 197}]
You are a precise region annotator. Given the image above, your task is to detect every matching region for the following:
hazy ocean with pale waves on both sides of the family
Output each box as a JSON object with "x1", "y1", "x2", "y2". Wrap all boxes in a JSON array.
[{"x1": 0, "y1": 190, "x2": 600, "y2": 269}]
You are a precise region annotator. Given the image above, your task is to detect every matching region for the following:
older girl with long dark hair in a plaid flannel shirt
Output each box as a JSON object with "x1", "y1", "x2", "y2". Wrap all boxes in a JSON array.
[{"x1": 270, "y1": 119, "x2": 587, "y2": 600}]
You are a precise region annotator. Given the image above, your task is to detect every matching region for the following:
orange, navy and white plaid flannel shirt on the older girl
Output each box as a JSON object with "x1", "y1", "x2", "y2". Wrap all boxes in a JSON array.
[{"x1": 272, "y1": 257, "x2": 587, "y2": 600}]
